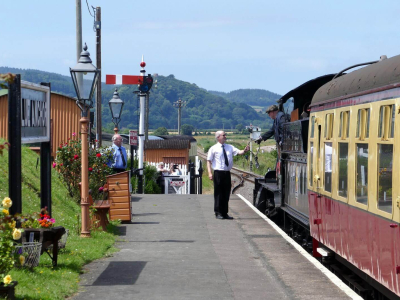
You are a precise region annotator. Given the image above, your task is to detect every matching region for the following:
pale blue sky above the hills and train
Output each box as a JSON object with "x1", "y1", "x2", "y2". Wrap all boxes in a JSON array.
[{"x1": 0, "y1": 0, "x2": 400, "y2": 94}]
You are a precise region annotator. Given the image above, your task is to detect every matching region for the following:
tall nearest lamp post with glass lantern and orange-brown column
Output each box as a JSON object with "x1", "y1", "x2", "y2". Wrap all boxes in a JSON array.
[{"x1": 69, "y1": 43, "x2": 100, "y2": 237}]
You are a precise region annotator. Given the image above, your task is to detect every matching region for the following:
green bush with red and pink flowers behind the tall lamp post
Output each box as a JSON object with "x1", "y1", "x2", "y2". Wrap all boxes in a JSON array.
[{"x1": 53, "y1": 133, "x2": 113, "y2": 202}]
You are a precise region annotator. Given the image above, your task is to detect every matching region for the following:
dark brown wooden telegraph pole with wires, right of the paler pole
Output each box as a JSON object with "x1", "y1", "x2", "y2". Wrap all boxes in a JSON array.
[{"x1": 95, "y1": 7, "x2": 102, "y2": 148}]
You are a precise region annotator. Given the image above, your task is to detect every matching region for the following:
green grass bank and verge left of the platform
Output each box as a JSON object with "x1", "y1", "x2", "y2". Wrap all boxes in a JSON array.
[{"x1": 0, "y1": 141, "x2": 118, "y2": 300}]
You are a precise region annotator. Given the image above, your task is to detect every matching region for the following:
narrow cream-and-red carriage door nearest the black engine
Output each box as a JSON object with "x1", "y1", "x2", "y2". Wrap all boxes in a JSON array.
[{"x1": 307, "y1": 114, "x2": 323, "y2": 241}]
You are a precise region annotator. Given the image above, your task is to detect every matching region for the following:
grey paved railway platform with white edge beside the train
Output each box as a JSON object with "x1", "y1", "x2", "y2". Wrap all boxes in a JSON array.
[{"x1": 73, "y1": 195, "x2": 360, "y2": 300}]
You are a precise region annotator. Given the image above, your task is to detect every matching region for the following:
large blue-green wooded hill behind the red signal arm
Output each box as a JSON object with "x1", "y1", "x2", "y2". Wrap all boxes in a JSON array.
[{"x1": 0, "y1": 67, "x2": 270, "y2": 129}]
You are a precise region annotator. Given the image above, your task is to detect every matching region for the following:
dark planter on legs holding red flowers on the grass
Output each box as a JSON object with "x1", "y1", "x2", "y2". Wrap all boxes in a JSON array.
[{"x1": 21, "y1": 226, "x2": 65, "y2": 267}]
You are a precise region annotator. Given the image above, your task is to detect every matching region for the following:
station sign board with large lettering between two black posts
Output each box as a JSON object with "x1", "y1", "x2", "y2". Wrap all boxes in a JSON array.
[{"x1": 21, "y1": 80, "x2": 50, "y2": 144}]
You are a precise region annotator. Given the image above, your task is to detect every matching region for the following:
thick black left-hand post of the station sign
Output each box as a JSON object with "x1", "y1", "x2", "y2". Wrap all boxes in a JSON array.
[{"x1": 8, "y1": 74, "x2": 22, "y2": 215}]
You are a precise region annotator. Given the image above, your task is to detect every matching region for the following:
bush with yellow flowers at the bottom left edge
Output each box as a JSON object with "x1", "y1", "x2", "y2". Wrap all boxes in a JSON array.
[{"x1": 0, "y1": 197, "x2": 24, "y2": 285}]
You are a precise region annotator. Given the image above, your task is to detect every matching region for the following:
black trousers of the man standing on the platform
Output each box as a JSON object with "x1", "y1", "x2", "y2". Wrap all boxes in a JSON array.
[{"x1": 214, "y1": 170, "x2": 231, "y2": 216}]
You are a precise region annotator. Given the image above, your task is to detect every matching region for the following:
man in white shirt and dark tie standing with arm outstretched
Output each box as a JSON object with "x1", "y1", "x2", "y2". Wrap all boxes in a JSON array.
[{"x1": 207, "y1": 131, "x2": 249, "y2": 219}]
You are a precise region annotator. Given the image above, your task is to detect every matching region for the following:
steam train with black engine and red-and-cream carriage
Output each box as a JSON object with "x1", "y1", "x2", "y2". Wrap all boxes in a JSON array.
[{"x1": 253, "y1": 56, "x2": 400, "y2": 298}]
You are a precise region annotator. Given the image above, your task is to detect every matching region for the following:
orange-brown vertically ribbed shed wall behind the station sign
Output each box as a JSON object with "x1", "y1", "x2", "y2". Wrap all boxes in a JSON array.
[{"x1": 0, "y1": 92, "x2": 81, "y2": 158}]
